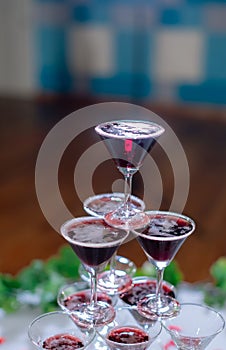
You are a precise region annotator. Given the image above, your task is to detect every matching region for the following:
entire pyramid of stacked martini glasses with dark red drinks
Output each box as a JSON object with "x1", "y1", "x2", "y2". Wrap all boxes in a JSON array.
[{"x1": 28, "y1": 116, "x2": 225, "y2": 350}]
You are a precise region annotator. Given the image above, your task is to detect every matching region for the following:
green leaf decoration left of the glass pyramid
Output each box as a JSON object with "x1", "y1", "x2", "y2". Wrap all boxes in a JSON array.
[{"x1": 0, "y1": 245, "x2": 80, "y2": 313}]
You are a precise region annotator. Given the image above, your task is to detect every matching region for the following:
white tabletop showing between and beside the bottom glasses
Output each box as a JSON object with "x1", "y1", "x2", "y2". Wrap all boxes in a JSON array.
[{"x1": 0, "y1": 283, "x2": 226, "y2": 350}]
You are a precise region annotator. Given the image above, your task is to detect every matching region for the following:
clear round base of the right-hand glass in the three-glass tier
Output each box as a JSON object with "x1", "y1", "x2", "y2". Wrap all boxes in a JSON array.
[{"x1": 137, "y1": 295, "x2": 180, "y2": 321}]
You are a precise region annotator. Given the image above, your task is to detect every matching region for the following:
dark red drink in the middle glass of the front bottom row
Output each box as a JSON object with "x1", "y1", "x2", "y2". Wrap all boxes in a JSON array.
[{"x1": 108, "y1": 327, "x2": 149, "y2": 344}]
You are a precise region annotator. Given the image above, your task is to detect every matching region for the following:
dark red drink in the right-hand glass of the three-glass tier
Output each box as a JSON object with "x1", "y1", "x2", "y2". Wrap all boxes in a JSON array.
[{"x1": 137, "y1": 214, "x2": 193, "y2": 261}]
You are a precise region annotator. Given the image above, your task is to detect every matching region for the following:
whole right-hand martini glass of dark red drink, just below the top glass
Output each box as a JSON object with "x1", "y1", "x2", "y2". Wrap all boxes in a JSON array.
[{"x1": 135, "y1": 211, "x2": 195, "y2": 320}]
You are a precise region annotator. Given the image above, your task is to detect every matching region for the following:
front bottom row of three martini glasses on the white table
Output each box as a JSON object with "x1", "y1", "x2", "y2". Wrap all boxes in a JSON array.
[{"x1": 28, "y1": 303, "x2": 225, "y2": 350}]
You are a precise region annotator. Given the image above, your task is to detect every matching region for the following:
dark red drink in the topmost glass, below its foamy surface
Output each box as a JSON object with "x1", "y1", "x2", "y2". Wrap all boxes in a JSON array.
[{"x1": 102, "y1": 137, "x2": 156, "y2": 169}]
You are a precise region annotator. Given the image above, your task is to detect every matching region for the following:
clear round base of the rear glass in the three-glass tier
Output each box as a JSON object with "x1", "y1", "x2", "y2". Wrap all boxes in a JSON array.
[{"x1": 97, "y1": 270, "x2": 133, "y2": 295}]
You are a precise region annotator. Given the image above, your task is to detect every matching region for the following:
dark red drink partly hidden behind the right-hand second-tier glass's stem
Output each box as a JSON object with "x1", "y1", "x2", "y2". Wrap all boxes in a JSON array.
[{"x1": 120, "y1": 281, "x2": 175, "y2": 305}]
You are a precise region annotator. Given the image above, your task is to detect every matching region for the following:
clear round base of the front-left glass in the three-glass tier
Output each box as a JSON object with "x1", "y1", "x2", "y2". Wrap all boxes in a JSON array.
[{"x1": 70, "y1": 301, "x2": 115, "y2": 327}]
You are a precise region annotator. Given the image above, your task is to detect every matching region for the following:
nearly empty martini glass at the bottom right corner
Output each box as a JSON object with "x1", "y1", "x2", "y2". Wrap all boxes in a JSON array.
[{"x1": 162, "y1": 303, "x2": 225, "y2": 350}]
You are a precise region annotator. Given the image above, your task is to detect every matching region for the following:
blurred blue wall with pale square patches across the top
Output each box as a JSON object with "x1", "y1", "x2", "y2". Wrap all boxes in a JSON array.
[{"x1": 0, "y1": 0, "x2": 226, "y2": 105}]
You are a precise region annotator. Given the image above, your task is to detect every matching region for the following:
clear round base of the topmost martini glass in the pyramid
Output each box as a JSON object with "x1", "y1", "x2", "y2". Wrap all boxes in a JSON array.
[{"x1": 104, "y1": 205, "x2": 150, "y2": 230}]
